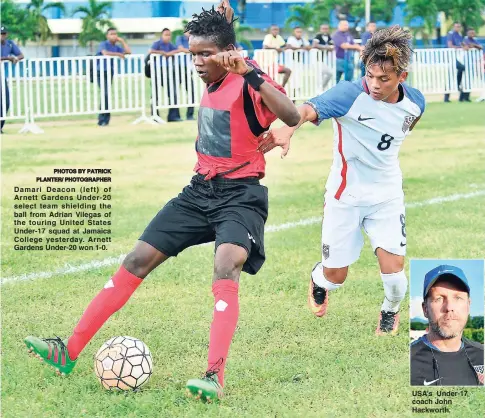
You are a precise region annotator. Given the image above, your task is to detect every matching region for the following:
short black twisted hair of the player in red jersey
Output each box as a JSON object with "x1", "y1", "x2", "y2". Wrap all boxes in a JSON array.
[{"x1": 184, "y1": 6, "x2": 237, "y2": 49}]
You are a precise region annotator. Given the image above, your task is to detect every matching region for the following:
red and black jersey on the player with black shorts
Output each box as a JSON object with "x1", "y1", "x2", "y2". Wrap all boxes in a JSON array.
[{"x1": 194, "y1": 60, "x2": 285, "y2": 180}]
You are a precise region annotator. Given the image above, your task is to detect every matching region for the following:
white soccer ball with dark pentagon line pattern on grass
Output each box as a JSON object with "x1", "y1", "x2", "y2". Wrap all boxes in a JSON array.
[{"x1": 94, "y1": 337, "x2": 153, "y2": 390}]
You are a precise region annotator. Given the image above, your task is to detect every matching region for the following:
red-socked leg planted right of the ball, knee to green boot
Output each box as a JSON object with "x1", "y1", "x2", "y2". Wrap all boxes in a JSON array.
[{"x1": 187, "y1": 243, "x2": 248, "y2": 402}]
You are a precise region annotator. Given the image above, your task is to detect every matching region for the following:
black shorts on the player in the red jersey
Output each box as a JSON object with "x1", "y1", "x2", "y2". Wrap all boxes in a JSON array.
[{"x1": 140, "y1": 174, "x2": 268, "y2": 274}]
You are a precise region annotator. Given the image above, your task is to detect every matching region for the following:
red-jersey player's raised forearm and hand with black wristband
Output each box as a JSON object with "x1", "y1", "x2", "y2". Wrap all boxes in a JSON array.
[{"x1": 209, "y1": 51, "x2": 300, "y2": 126}]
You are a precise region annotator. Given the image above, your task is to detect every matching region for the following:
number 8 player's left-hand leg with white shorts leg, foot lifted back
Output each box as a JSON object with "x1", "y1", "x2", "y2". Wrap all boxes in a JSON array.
[{"x1": 308, "y1": 197, "x2": 364, "y2": 317}]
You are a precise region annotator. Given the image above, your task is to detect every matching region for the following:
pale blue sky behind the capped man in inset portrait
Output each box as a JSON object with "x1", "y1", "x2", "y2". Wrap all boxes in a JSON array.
[{"x1": 409, "y1": 259, "x2": 485, "y2": 319}]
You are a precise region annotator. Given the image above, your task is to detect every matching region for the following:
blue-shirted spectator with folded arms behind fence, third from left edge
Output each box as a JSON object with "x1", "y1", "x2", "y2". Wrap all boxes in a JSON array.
[{"x1": 149, "y1": 28, "x2": 182, "y2": 122}]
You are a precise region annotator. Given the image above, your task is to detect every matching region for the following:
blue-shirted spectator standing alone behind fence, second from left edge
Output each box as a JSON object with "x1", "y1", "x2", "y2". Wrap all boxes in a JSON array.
[{"x1": 96, "y1": 28, "x2": 131, "y2": 126}]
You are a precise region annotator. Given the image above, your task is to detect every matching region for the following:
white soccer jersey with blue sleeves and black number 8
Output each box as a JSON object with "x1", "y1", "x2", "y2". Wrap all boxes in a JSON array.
[{"x1": 306, "y1": 77, "x2": 425, "y2": 206}]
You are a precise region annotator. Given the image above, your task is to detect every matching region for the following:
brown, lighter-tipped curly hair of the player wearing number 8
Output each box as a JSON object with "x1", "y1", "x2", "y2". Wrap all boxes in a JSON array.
[{"x1": 362, "y1": 25, "x2": 413, "y2": 75}]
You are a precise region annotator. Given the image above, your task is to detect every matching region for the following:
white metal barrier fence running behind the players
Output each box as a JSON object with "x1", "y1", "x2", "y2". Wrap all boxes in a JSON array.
[{"x1": 0, "y1": 49, "x2": 485, "y2": 132}]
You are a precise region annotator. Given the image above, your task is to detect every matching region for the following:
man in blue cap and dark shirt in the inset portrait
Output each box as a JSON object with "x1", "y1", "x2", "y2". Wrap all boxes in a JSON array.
[{"x1": 411, "y1": 265, "x2": 484, "y2": 386}]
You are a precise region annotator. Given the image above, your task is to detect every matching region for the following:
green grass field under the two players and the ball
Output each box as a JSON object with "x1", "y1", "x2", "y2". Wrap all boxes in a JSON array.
[{"x1": 1, "y1": 99, "x2": 485, "y2": 418}]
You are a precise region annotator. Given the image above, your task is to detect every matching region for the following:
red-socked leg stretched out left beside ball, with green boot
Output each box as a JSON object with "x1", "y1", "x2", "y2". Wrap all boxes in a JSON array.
[{"x1": 25, "y1": 241, "x2": 168, "y2": 374}]
